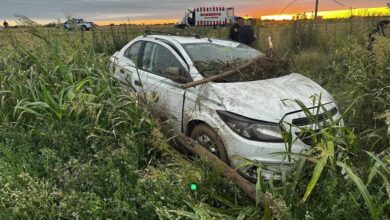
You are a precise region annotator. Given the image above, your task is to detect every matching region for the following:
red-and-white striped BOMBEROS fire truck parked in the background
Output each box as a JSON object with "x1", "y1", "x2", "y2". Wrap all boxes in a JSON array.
[{"x1": 175, "y1": 6, "x2": 234, "y2": 29}]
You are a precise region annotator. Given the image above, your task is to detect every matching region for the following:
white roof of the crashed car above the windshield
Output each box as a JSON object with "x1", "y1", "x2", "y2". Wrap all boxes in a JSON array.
[{"x1": 144, "y1": 35, "x2": 240, "y2": 47}]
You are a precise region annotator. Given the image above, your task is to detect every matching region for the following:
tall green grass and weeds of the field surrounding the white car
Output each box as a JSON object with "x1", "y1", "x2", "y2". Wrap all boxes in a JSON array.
[{"x1": 0, "y1": 18, "x2": 390, "y2": 219}]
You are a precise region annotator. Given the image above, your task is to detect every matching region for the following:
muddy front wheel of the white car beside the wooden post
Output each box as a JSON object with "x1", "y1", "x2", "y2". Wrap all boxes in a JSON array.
[{"x1": 191, "y1": 124, "x2": 229, "y2": 164}]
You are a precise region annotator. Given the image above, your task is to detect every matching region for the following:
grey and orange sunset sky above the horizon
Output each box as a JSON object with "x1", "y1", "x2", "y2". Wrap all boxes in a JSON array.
[{"x1": 0, "y1": 0, "x2": 390, "y2": 24}]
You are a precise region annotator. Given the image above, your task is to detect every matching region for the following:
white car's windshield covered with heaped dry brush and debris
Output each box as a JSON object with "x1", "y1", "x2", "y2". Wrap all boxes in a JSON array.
[{"x1": 183, "y1": 42, "x2": 289, "y2": 82}]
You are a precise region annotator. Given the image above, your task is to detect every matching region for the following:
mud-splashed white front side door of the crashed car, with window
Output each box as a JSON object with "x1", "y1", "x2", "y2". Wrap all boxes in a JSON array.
[{"x1": 135, "y1": 40, "x2": 191, "y2": 132}]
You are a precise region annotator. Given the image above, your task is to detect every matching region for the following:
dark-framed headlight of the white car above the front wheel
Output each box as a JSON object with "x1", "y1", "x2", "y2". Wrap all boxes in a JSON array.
[{"x1": 217, "y1": 111, "x2": 284, "y2": 143}]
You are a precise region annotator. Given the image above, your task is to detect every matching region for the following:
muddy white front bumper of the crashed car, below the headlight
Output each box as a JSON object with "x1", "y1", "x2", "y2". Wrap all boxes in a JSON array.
[{"x1": 218, "y1": 105, "x2": 344, "y2": 179}]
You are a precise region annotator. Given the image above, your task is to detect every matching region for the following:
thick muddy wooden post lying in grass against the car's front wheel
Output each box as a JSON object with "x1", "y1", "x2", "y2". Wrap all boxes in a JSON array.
[{"x1": 176, "y1": 133, "x2": 267, "y2": 207}]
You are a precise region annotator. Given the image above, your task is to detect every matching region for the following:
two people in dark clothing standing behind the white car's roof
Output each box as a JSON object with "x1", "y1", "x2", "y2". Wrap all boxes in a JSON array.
[{"x1": 229, "y1": 17, "x2": 256, "y2": 46}]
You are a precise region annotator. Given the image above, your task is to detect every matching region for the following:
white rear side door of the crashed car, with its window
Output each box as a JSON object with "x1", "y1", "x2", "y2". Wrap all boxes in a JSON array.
[{"x1": 114, "y1": 41, "x2": 143, "y2": 92}]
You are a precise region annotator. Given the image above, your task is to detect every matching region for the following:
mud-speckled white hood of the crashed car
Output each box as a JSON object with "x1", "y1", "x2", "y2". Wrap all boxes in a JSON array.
[{"x1": 211, "y1": 73, "x2": 334, "y2": 122}]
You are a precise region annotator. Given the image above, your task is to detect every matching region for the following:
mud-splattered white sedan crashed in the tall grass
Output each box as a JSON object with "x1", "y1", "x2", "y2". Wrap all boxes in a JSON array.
[{"x1": 110, "y1": 35, "x2": 342, "y2": 177}]
